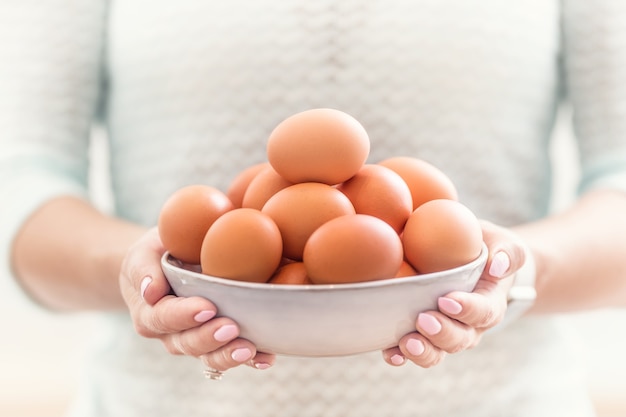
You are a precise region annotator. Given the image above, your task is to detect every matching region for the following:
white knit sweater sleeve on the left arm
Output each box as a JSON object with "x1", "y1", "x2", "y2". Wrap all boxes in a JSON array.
[{"x1": 0, "y1": 0, "x2": 105, "y2": 306}]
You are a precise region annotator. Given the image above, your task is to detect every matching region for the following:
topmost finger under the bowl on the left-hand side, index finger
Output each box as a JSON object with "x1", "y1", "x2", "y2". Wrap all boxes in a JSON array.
[{"x1": 131, "y1": 295, "x2": 217, "y2": 338}]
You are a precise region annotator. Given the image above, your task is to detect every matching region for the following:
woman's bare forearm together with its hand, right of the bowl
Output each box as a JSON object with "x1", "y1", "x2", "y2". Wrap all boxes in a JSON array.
[{"x1": 383, "y1": 189, "x2": 626, "y2": 367}]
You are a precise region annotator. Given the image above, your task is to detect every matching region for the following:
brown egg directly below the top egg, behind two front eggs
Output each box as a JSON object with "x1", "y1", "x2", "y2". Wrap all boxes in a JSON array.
[{"x1": 262, "y1": 182, "x2": 355, "y2": 260}]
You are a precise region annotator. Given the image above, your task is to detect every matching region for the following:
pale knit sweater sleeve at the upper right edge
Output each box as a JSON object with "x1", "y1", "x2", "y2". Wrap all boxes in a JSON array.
[{"x1": 563, "y1": 0, "x2": 626, "y2": 192}]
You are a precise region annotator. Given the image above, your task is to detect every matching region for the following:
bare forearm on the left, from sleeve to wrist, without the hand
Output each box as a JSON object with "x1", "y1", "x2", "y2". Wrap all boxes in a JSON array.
[{"x1": 11, "y1": 197, "x2": 146, "y2": 310}]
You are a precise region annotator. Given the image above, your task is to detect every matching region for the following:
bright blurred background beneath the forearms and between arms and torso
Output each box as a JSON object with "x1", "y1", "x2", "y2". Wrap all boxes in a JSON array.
[{"x1": 0, "y1": 108, "x2": 626, "y2": 417}]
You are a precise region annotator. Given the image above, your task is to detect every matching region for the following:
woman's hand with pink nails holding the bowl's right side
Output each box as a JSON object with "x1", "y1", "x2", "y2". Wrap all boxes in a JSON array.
[{"x1": 383, "y1": 221, "x2": 525, "y2": 368}]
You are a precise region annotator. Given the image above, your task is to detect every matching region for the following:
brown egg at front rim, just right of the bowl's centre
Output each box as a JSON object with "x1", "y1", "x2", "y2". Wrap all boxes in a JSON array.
[{"x1": 303, "y1": 214, "x2": 403, "y2": 284}]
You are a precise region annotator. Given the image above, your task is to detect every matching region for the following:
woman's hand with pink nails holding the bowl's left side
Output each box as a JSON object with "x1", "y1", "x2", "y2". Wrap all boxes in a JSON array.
[{"x1": 120, "y1": 228, "x2": 275, "y2": 371}]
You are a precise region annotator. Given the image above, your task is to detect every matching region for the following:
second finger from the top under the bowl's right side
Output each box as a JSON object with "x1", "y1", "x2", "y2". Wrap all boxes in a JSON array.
[{"x1": 415, "y1": 311, "x2": 480, "y2": 353}]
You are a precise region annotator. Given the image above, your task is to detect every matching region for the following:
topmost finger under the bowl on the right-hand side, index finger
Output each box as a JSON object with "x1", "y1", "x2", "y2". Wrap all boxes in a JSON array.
[{"x1": 437, "y1": 277, "x2": 513, "y2": 329}]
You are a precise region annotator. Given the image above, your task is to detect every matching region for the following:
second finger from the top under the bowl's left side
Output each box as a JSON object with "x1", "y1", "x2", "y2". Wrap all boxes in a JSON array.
[{"x1": 161, "y1": 317, "x2": 239, "y2": 359}]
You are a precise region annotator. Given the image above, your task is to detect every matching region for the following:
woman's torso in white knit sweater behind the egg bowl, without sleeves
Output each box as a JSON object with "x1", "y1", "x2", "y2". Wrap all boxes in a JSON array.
[{"x1": 70, "y1": 0, "x2": 589, "y2": 417}]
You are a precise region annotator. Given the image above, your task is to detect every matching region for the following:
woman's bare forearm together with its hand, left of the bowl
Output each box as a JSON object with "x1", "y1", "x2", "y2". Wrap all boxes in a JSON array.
[{"x1": 12, "y1": 197, "x2": 274, "y2": 371}]
